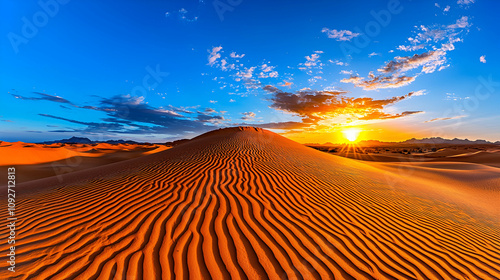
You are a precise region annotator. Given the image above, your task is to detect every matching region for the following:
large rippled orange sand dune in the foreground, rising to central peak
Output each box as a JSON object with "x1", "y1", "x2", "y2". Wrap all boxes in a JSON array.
[{"x1": 0, "y1": 128, "x2": 500, "y2": 280}]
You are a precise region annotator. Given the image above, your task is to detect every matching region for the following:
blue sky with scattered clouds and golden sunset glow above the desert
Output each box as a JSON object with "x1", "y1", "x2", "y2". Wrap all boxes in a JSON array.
[{"x1": 0, "y1": 0, "x2": 500, "y2": 142}]
